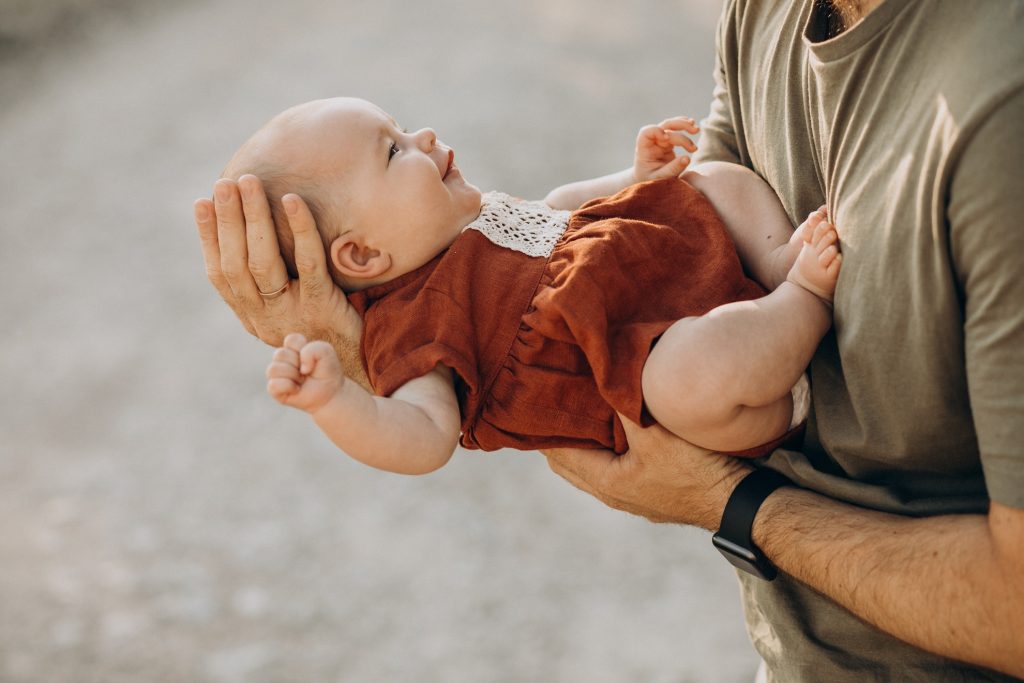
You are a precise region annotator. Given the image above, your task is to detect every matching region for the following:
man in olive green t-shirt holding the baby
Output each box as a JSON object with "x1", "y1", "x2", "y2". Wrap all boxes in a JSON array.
[{"x1": 197, "y1": 0, "x2": 1024, "y2": 681}]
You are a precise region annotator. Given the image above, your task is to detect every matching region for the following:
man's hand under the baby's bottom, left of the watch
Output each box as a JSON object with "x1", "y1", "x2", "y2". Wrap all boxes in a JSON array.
[{"x1": 543, "y1": 415, "x2": 750, "y2": 529}]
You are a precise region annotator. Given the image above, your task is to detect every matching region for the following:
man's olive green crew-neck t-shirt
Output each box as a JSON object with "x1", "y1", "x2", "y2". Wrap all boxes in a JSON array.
[{"x1": 695, "y1": 0, "x2": 1024, "y2": 683}]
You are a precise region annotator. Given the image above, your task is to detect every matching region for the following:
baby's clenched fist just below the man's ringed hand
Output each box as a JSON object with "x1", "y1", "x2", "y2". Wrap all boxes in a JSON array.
[{"x1": 266, "y1": 333, "x2": 345, "y2": 413}]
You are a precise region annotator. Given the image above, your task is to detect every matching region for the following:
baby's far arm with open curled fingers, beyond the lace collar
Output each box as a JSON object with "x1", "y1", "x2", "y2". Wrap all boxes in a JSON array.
[{"x1": 544, "y1": 117, "x2": 699, "y2": 211}]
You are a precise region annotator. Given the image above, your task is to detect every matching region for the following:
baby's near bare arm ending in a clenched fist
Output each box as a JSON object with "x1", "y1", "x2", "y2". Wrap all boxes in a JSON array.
[{"x1": 266, "y1": 334, "x2": 460, "y2": 474}]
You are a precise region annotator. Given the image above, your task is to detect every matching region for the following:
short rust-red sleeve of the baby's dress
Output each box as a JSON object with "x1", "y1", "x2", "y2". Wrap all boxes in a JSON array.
[{"x1": 362, "y1": 290, "x2": 479, "y2": 396}]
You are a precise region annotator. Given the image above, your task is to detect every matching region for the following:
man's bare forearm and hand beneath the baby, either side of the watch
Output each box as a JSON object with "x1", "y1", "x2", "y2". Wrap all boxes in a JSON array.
[{"x1": 545, "y1": 418, "x2": 1024, "y2": 676}]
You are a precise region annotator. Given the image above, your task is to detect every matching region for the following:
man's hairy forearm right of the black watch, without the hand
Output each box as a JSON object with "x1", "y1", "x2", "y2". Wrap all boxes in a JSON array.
[{"x1": 754, "y1": 487, "x2": 1024, "y2": 677}]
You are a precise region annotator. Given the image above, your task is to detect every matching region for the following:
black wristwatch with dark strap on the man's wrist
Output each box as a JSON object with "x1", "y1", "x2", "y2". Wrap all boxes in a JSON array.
[{"x1": 712, "y1": 467, "x2": 794, "y2": 581}]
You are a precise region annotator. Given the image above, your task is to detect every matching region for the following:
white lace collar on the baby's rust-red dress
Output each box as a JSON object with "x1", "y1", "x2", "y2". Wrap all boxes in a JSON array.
[{"x1": 465, "y1": 193, "x2": 571, "y2": 258}]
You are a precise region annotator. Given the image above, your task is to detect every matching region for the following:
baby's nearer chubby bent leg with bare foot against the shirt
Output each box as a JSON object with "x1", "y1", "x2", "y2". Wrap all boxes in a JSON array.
[{"x1": 642, "y1": 210, "x2": 841, "y2": 451}]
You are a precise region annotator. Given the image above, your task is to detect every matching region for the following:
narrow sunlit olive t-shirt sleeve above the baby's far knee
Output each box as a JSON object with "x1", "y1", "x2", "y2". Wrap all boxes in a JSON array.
[{"x1": 693, "y1": 0, "x2": 740, "y2": 164}]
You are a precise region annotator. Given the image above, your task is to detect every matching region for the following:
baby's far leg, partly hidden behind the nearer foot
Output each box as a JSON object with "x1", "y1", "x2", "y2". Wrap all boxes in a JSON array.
[{"x1": 683, "y1": 162, "x2": 804, "y2": 290}]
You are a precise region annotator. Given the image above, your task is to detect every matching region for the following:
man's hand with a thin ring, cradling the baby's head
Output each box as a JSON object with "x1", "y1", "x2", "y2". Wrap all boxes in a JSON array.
[{"x1": 195, "y1": 175, "x2": 369, "y2": 387}]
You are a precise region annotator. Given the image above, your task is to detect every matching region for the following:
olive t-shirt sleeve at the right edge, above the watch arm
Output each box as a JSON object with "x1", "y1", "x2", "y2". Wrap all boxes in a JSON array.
[{"x1": 948, "y1": 88, "x2": 1024, "y2": 508}]
